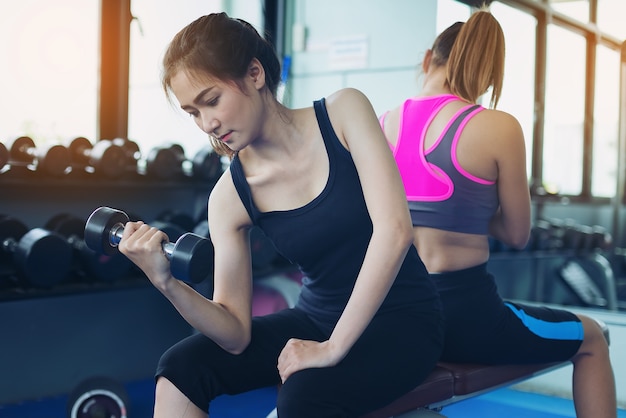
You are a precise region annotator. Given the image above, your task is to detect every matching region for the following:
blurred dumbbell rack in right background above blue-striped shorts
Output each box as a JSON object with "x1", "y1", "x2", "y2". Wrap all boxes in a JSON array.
[{"x1": 489, "y1": 218, "x2": 618, "y2": 310}]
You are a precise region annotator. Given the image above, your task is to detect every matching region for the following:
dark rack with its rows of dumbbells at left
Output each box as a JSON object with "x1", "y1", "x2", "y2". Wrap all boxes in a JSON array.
[{"x1": 0, "y1": 136, "x2": 266, "y2": 415}]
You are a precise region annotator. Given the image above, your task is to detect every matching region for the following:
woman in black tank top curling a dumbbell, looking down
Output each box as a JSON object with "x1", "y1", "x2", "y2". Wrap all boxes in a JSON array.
[{"x1": 113, "y1": 13, "x2": 443, "y2": 418}]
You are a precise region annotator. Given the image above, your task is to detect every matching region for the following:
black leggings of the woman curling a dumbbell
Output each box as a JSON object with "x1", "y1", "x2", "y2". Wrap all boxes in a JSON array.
[{"x1": 156, "y1": 308, "x2": 443, "y2": 418}]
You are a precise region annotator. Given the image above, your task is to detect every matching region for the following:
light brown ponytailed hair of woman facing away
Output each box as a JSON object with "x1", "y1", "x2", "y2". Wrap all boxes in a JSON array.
[{"x1": 432, "y1": 8, "x2": 505, "y2": 108}]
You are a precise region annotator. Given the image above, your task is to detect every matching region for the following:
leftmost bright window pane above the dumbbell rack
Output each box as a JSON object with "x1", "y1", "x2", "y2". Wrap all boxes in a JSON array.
[{"x1": 0, "y1": 0, "x2": 100, "y2": 145}]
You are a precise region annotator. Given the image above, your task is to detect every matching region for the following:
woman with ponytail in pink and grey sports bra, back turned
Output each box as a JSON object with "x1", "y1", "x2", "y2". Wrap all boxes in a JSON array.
[{"x1": 381, "y1": 9, "x2": 617, "y2": 418}]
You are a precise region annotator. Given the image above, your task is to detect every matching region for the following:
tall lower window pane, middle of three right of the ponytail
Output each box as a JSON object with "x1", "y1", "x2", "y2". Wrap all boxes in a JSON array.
[{"x1": 543, "y1": 25, "x2": 585, "y2": 195}]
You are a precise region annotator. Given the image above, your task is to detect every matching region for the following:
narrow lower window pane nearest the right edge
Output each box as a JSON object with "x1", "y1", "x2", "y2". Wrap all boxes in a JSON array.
[{"x1": 591, "y1": 46, "x2": 620, "y2": 197}]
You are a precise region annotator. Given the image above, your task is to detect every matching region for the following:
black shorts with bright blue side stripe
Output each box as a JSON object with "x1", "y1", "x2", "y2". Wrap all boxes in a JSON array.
[{"x1": 431, "y1": 264, "x2": 584, "y2": 364}]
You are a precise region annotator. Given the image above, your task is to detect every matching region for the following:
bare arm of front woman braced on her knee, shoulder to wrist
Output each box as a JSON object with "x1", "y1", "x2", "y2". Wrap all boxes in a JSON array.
[{"x1": 327, "y1": 89, "x2": 413, "y2": 361}]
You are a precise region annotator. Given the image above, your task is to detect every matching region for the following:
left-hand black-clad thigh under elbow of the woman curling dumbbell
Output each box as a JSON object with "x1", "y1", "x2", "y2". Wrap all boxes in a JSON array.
[{"x1": 156, "y1": 309, "x2": 323, "y2": 410}]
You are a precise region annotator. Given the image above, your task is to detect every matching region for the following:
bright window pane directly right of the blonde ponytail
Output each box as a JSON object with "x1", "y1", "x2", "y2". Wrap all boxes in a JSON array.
[{"x1": 486, "y1": 3, "x2": 537, "y2": 180}]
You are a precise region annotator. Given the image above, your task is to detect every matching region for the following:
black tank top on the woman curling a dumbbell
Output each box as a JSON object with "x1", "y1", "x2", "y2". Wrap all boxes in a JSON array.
[{"x1": 230, "y1": 99, "x2": 439, "y2": 333}]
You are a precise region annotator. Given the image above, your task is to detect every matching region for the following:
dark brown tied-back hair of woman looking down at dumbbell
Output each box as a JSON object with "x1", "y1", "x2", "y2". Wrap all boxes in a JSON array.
[{"x1": 161, "y1": 13, "x2": 280, "y2": 157}]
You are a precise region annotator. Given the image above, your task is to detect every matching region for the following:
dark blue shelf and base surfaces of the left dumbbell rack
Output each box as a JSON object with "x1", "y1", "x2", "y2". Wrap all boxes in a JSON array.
[{"x1": 0, "y1": 172, "x2": 214, "y2": 405}]
